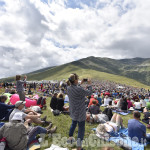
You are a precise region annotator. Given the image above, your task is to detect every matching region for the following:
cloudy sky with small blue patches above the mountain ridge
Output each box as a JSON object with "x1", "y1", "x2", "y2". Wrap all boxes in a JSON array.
[{"x1": 0, "y1": 0, "x2": 150, "y2": 78}]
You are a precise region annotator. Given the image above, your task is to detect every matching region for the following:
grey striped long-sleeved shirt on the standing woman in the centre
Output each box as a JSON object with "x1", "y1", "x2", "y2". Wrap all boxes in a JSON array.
[{"x1": 67, "y1": 85, "x2": 92, "y2": 122}]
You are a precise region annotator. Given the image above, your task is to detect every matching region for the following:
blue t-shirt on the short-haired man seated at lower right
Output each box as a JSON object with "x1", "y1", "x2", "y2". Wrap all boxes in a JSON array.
[{"x1": 128, "y1": 119, "x2": 146, "y2": 143}]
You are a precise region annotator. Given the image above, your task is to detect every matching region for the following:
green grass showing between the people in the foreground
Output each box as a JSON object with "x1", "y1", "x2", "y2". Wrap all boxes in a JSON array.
[{"x1": 0, "y1": 86, "x2": 150, "y2": 150}]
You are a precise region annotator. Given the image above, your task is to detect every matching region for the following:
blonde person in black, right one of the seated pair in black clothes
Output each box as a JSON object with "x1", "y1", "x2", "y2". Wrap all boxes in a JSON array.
[{"x1": 56, "y1": 93, "x2": 69, "y2": 111}]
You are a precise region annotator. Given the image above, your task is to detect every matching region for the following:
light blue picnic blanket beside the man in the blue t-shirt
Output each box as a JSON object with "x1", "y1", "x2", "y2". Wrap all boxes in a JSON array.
[{"x1": 95, "y1": 128, "x2": 149, "y2": 150}]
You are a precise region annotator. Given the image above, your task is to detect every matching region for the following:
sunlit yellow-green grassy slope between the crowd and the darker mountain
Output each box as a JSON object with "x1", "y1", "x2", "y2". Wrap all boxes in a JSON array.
[{"x1": 41, "y1": 65, "x2": 150, "y2": 89}]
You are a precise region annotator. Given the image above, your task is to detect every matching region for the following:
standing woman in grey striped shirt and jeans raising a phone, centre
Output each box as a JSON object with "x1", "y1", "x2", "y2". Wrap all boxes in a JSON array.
[{"x1": 67, "y1": 73, "x2": 93, "y2": 150}]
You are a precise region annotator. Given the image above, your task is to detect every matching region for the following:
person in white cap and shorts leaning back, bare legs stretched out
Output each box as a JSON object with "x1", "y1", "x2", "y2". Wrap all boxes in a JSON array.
[{"x1": 9, "y1": 101, "x2": 49, "y2": 125}]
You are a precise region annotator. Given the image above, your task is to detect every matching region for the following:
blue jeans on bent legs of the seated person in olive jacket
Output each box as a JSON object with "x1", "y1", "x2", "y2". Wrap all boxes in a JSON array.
[{"x1": 28, "y1": 126, "x2": 47, "y2": 145}]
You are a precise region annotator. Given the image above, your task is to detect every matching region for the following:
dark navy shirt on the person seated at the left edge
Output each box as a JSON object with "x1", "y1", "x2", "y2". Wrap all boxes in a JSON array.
[{"x1": 0, "y1": 102, "x2": 15, "y2": 119}]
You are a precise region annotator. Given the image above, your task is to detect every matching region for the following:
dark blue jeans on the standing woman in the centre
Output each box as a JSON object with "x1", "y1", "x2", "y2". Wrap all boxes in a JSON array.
[{"x1": 69, "y1": 120, "x2": 85, "y2": 146}]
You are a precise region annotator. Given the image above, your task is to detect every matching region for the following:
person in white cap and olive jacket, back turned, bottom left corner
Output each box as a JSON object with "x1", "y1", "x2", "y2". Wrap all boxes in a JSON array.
[{"x1": 0, "y1": 112, "x2": 28, "y2": 150}]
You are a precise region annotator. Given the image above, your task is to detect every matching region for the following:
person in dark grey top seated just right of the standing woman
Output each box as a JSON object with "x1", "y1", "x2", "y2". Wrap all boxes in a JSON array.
[{"x1": 88, "y1": 100, "x2": 100, "y2": 115}]
